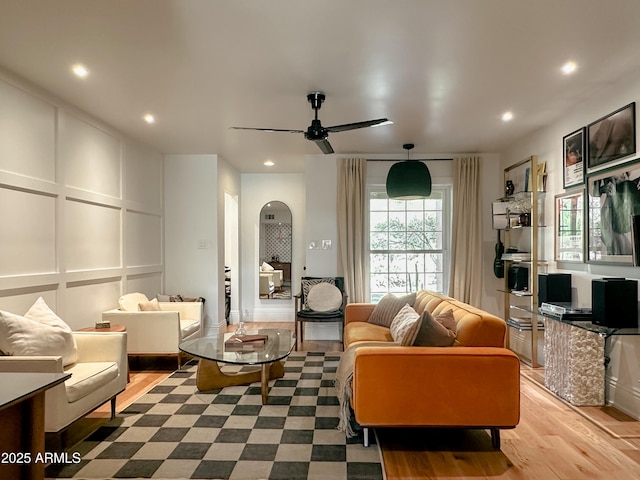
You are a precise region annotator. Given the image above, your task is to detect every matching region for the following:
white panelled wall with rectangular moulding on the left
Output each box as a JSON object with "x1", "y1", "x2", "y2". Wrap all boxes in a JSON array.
[{"x1": 0, "y1": 71, "x2": 164, "y2": 328}]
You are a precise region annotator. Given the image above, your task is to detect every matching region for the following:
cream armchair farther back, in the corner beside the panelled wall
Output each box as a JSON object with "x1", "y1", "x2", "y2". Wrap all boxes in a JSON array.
[{"x1": 102, "y1": 294, "x2": 203, "y2": 368}]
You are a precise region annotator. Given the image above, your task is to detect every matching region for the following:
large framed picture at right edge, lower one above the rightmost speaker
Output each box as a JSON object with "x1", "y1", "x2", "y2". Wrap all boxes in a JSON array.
[{"x1": 586, "y1": 161, "x2": 640, "y2": 265}]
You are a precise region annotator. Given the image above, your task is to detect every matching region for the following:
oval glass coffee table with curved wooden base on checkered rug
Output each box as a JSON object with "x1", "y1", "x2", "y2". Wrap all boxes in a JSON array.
[{"x1": 179, "y1": 329, "x2": 295, "y2": 405}]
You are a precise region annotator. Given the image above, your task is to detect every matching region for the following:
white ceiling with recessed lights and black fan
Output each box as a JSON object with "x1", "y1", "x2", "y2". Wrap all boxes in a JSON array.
[{"x1": 0, "y1": 0, "x2": 640, "y2": 172}]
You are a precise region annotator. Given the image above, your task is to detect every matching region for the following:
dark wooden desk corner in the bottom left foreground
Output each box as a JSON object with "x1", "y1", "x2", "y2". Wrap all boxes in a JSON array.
[{"x1": 0, "y1": 372, "x2": 71, "y2": 480}]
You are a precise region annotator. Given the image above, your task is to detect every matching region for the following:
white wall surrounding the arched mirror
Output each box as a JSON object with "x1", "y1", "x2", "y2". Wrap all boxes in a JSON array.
[{"x1": 242, "y1": 173, "x2": 308, "y2": 322}]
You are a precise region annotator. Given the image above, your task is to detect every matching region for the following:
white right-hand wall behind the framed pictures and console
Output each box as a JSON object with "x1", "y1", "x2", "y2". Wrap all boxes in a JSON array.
[{"x1": 500, "y1": 69, "x2": 640, "y2": 418}]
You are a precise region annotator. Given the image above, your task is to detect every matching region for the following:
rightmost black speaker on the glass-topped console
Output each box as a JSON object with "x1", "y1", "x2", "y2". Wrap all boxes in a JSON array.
[{"x1": 591, "y1": 278, "x2": 638, "y2": 328}]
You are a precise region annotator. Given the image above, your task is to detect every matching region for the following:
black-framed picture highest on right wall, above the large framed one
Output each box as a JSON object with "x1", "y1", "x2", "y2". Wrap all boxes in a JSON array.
[{"x1": 587, "y1": 102, "x2": 636, "y2": 169}]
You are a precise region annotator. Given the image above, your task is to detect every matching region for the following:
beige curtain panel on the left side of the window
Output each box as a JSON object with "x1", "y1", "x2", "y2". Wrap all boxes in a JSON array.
[{"x1": 337, "y1": 158, "x2": 368, "y2": 302}]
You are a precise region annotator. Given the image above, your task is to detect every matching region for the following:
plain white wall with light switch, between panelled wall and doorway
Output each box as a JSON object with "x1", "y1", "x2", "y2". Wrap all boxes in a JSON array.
[{"x1": 164, "y1": 155, "x2": 239, "y2": 334}]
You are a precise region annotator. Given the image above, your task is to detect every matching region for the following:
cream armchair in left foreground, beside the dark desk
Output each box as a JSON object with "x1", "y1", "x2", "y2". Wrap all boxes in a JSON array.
[{"x1": 0, "y1": 332, "x2": 127, "y2": 432}]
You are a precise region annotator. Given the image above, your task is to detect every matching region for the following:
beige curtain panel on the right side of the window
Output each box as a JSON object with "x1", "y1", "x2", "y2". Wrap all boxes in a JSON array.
[{"x1": 449, "y1": 157, "x2": 482, "y2": 306}]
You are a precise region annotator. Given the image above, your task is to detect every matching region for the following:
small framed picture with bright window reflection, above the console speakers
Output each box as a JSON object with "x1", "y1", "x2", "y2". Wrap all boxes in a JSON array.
[{"x1": 555, "y1": 190, "x2": 585, "y2": 263}]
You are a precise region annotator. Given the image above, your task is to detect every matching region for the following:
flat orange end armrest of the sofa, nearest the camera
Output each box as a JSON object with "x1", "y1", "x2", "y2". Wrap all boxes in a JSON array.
[{"x1": 352, "y1": 346, "x2": 520, "y2": 427}]
